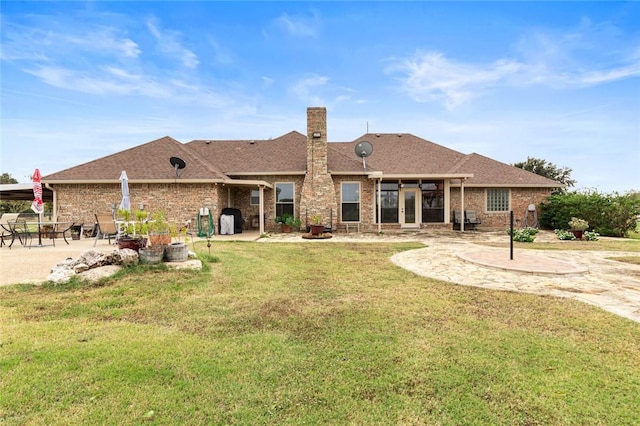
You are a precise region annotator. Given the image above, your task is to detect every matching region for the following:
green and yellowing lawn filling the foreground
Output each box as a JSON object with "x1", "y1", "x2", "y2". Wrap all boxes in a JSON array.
[{"x1": 0, "y1": 243, "x2": 640, "y2": 425}]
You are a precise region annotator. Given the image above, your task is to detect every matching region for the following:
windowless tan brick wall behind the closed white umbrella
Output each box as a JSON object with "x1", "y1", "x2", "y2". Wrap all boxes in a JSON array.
[{"x1": 54, "y1": 183, "x2": 221, "y2": 232}]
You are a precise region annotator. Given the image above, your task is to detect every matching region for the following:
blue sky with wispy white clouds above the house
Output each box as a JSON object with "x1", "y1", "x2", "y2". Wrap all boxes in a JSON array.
[{"x1": 0, "y1": 1, "x2": 640, "y2": 192}]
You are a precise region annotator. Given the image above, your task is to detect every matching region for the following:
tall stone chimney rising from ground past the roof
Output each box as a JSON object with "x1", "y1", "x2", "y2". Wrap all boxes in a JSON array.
[{"x1": 300, "y1": 107, "x2": 338, "y2": 228}]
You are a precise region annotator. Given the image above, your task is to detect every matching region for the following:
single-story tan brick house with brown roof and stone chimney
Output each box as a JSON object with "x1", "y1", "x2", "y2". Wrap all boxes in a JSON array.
[{"x1": 42, "y1": 107, "x2": 562, "y2": 232}]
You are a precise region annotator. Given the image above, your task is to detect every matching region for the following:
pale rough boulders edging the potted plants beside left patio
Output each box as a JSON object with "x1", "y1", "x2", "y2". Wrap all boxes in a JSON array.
[{"x1": 47, "y1": 249, "x2": 202, "y2": 284}]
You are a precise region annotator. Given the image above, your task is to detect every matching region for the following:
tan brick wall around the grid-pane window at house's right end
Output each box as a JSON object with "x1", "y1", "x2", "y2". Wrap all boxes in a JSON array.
[{"x1": 450, "y1": 187, "x2": 552, "y2": 229}]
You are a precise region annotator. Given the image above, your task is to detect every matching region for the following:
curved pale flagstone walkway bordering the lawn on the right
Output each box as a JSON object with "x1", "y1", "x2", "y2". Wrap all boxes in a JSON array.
[{"x1": 391, "y1": 233, "x2": 640, "y2": 322}]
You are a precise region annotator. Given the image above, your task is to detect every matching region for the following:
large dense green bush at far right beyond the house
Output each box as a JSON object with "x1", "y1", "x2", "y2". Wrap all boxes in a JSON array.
[{"x1": 539, "y1": 191, "x2": 640, "y2": 237}]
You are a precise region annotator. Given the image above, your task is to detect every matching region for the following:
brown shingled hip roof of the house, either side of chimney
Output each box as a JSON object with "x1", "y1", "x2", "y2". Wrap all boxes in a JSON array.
[{"x1": 42, "y1": 131, "x2": 562, "y2": 187}]
